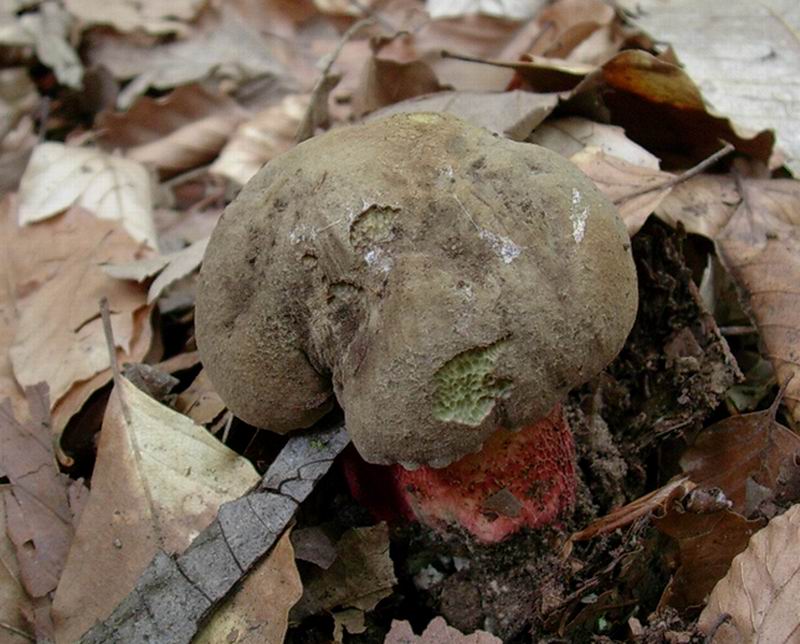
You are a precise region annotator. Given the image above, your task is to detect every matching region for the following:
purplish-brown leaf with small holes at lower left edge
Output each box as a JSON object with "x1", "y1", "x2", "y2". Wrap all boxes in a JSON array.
[{"x1": 0, "y1": 385, "x2": 74, "y2": 598}]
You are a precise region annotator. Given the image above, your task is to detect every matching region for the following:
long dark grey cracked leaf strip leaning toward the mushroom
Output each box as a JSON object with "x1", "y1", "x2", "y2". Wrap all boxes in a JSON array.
[{"x1": 82, "y1": 425, "x2": 349, "y2": 644}]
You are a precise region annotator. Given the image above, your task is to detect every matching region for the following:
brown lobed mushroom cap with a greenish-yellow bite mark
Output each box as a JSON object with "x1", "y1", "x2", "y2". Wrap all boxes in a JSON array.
[{"x1": 196, "y1": 114, "x2": 637, "y2": 467}]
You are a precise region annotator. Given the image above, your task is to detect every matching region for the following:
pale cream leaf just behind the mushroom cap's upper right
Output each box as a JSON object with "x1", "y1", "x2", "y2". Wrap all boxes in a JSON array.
[{"x1": 528, "y1": 116, "x2": 659, "y2": 170}]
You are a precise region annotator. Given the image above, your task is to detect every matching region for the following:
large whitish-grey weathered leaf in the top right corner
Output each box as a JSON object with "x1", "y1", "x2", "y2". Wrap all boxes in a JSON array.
[{"x1": 635, "y1": 0, "x2": 800, "y2": 176}]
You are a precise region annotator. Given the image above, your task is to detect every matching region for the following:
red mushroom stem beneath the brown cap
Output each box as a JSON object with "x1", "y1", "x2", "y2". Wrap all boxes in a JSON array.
[{"x1": 343, "y1": 405, "x2": 575, "y2": 543}]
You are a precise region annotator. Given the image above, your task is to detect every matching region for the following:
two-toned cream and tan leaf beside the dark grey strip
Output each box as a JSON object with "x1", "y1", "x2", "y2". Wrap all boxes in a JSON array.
[{"x1": 53, "y1": 378, "x2": 259, "y2": 642}]
